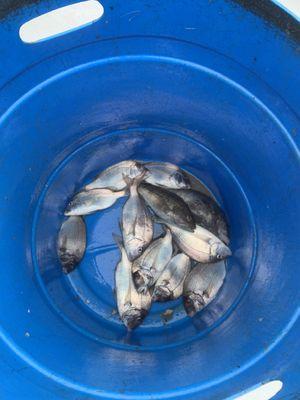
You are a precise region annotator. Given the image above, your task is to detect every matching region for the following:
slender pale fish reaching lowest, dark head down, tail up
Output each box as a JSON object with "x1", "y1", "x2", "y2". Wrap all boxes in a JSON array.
[{"x1": 115, "y1": 237, "x2": 151, "y2": 329}]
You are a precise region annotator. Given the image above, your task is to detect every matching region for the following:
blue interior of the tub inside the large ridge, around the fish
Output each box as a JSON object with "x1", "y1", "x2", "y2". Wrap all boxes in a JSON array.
[{"x1": 1, "y1": 42, "x2": 298, "y2": 398}]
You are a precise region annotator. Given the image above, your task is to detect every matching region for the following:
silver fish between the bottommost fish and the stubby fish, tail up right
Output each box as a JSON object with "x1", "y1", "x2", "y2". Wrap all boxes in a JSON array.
[{"x1": 132, "y1": 229, "x2": 173, "y2": 293}]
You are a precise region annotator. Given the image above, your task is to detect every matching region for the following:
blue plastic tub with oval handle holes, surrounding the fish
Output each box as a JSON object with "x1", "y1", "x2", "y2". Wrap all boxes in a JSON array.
[{"x1": 0, "y1": 0, "x2": 300, "y2": 400}]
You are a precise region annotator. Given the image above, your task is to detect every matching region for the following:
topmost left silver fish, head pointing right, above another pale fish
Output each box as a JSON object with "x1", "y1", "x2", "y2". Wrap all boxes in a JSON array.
[{"x1": 85, "y1": 160, "x2": 146, "y2": 191}]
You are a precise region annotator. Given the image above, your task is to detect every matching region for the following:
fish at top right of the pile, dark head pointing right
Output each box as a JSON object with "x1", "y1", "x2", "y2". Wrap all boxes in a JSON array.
[{"x1": 144, "y1": 162, "x2": 190, "y2": 189}]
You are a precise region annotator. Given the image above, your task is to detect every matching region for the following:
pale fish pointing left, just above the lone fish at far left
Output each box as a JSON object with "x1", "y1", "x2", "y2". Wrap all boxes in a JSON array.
[{"x1": 65, "y1": 189, "x2": 126, "y2": 216}]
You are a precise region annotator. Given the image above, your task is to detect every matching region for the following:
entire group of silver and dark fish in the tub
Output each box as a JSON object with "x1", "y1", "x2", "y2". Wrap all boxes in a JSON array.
[{"x1": 57, "y1": 160, "x2": 231, "y2": 329}]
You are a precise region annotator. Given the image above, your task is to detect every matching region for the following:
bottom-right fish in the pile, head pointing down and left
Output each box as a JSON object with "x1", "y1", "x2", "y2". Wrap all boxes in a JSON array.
[{"x1": 183, "y1": 262, "x2": 226, "y2": 317}]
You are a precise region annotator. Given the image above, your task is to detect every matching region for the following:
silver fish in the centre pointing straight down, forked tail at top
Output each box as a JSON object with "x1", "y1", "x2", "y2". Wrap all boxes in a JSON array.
[{"x1": 121, "y1": 174, "x2": 153, "y2": 261}]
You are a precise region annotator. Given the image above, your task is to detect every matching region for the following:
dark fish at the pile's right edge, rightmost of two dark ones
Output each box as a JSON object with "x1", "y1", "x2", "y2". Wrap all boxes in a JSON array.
[{"x1": 171, "y1": 190, "x2": 229, "y2": 245}]
